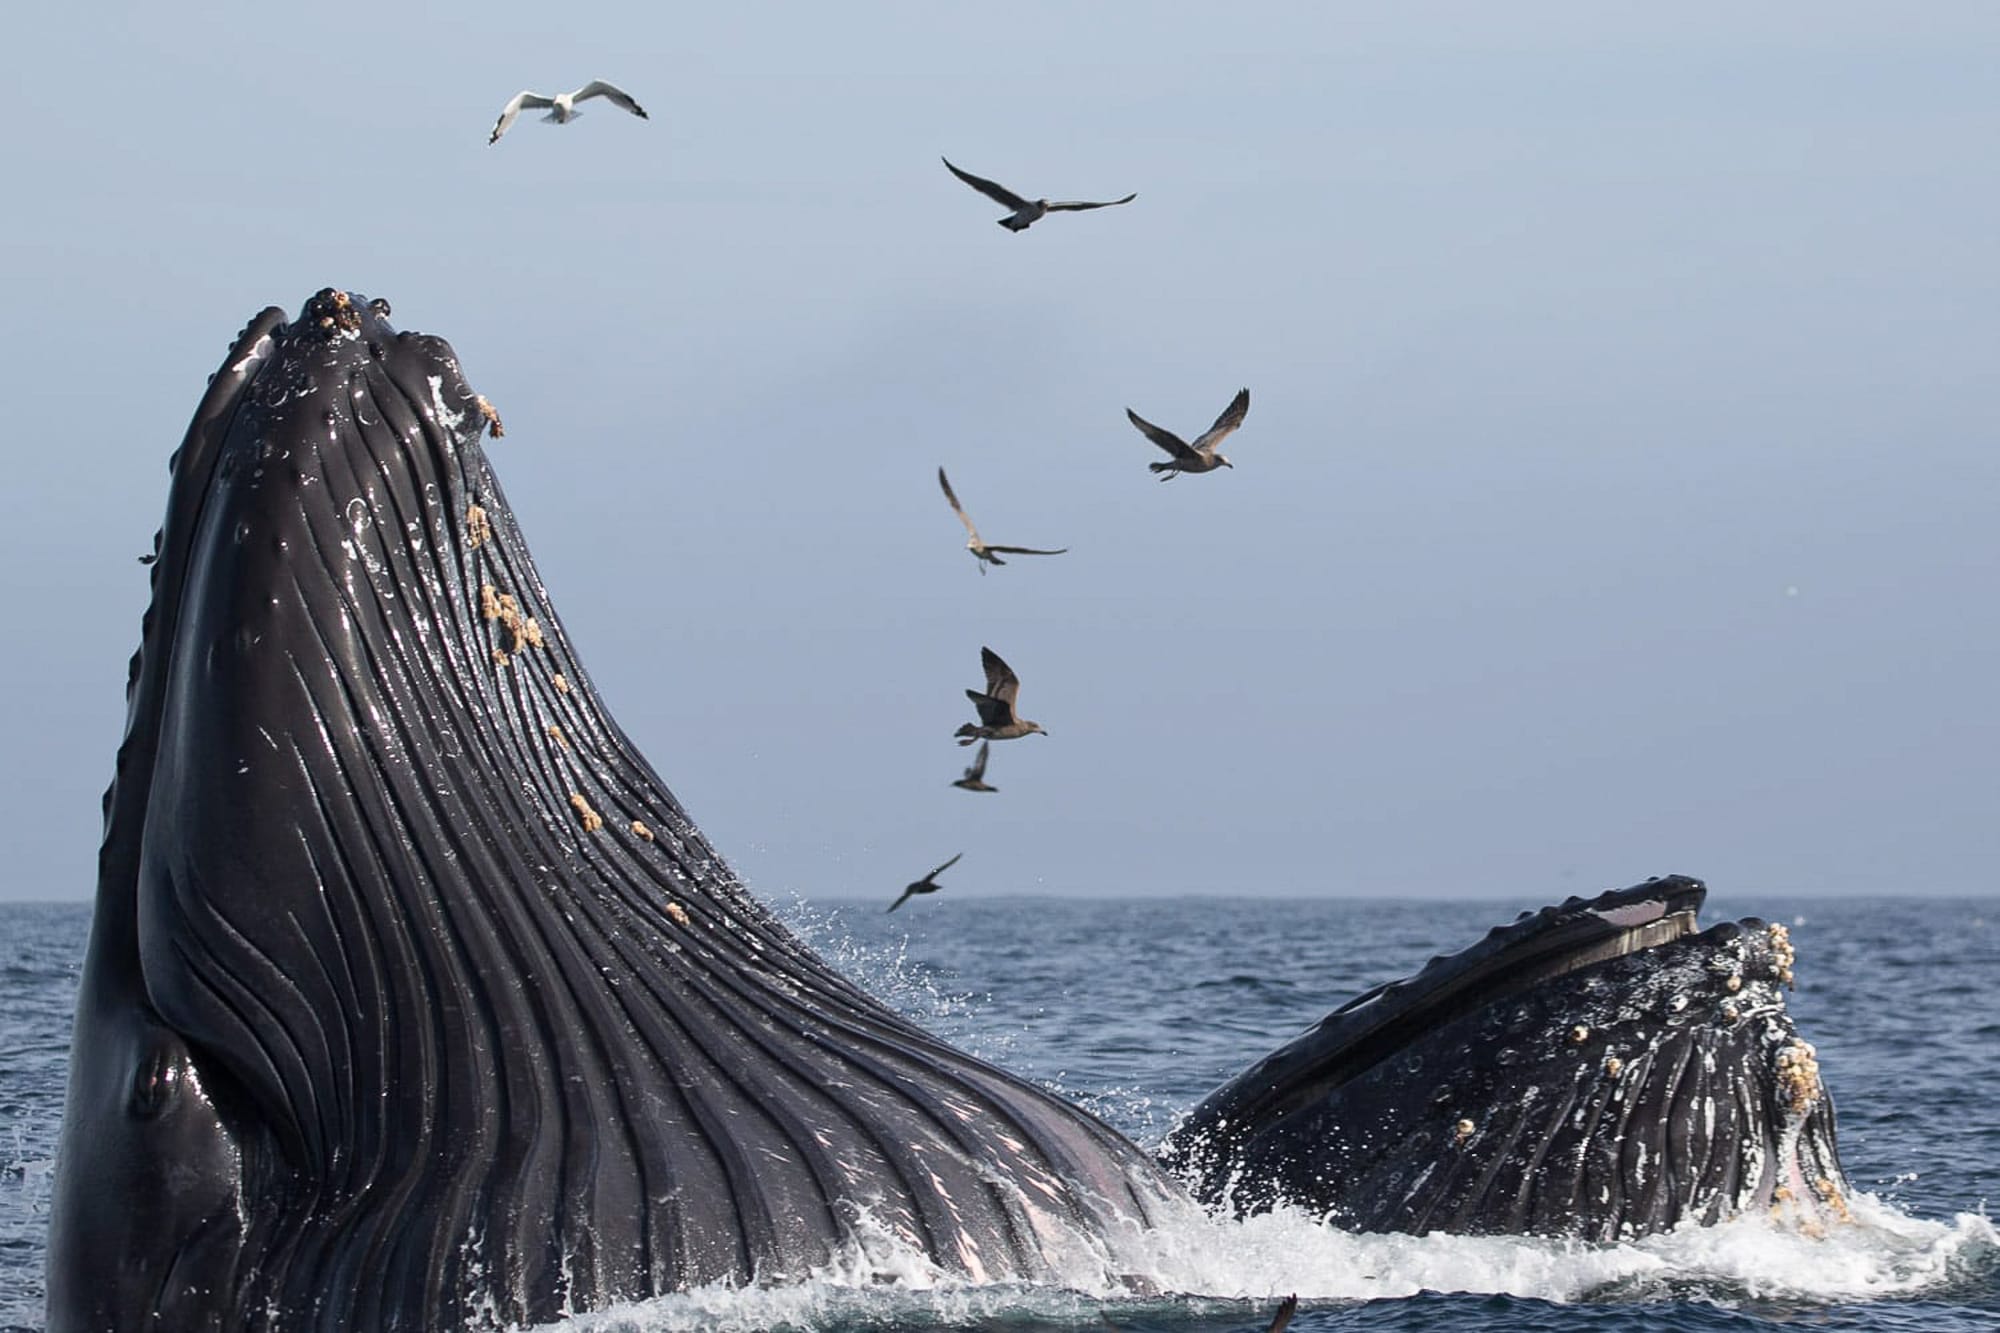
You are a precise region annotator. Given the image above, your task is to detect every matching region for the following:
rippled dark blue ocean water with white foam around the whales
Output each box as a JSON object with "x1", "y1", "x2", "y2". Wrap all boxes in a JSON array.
[{"x1": 0, "y1": 891, "x2": 2000, "y2": 1333}]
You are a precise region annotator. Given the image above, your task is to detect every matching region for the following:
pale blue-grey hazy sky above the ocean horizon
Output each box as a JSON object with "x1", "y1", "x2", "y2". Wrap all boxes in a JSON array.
[{"x1": 0, "y1": 2, "x2": 2000, "y2": 899}]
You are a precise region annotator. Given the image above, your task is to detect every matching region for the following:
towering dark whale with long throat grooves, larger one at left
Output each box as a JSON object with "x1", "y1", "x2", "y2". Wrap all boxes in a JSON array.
[{"x1": 50, "y1": 290, "x2": 1186, "y2": 1333}]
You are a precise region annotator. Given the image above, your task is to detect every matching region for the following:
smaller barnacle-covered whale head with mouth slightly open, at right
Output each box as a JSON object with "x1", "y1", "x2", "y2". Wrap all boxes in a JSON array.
[{"x1": 1162, "y1": 877, "x2": 1846, "y2": 1239}]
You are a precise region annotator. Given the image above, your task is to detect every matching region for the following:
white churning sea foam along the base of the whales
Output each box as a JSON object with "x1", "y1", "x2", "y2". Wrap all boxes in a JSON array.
[{"x1": 524, "y1": 1195, "x2": 2000, "y2": 1333}]
